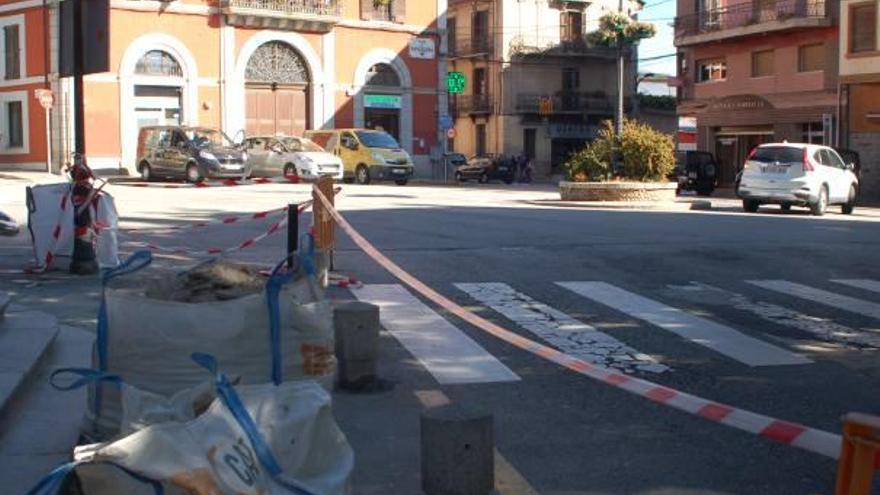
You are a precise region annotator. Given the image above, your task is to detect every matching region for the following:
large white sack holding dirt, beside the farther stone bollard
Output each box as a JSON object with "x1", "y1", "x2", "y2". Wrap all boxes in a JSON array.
[{"x1": 83, "y1": 252, "x2": 336, "y2": 440}]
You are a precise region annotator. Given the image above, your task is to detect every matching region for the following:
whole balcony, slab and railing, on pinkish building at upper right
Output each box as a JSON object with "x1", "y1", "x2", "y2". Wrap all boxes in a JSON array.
[{"x1": 675, "y1": 0, "x2": 832, "y2": 46}]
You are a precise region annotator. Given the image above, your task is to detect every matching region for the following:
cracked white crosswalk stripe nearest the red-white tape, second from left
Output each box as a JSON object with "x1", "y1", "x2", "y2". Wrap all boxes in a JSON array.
[{"x1": 454, "y1": 282, "x2": 669, "y2": 373}]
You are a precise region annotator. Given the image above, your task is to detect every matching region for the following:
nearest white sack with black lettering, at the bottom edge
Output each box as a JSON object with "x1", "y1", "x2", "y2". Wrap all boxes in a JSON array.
[{"x1": 74, "y1": 380, "x2": 354, "y2": 495}]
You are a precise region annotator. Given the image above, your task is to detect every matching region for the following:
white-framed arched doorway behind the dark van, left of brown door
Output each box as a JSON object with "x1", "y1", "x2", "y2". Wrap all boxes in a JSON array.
[{"x1": 134, "y1": 50, "x2": 185, "y2": 129}]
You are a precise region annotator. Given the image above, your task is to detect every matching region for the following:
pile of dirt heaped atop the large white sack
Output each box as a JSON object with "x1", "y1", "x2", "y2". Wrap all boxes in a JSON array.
[{"x1": 146, "y1": 261, "x2": 266, "y2": 303}]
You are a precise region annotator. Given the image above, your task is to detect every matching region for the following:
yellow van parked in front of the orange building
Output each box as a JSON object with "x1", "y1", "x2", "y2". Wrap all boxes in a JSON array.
[{"x1": 304, "y1": 129, "x2": 414, "y2": 186}]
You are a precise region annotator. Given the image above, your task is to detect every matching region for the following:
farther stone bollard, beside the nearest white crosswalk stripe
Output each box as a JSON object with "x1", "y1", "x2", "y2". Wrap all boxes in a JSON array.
[{"x1": 333, "y1": 301, "x2": 379, "y2": 390}]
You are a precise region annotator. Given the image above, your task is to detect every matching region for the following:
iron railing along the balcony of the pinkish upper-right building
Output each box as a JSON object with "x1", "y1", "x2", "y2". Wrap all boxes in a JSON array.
[{"x1": 675, "y1": 0, "x2": 826, "y2": 37}]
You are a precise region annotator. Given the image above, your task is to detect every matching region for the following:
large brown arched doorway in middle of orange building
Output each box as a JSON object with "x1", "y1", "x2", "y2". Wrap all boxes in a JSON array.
[{"x1": 245, "y1": 41, "x2": 312, "y2": 136}]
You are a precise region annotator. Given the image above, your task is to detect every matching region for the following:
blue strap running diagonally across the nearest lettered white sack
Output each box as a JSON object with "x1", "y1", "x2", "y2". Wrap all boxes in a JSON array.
[{"x1": 192, "y1": 352, "x2": 316, "y2": 495}]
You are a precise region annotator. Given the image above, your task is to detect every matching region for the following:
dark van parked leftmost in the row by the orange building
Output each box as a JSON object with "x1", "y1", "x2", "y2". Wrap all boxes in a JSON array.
[{"x1": 137, "y1": 126, "x2": 251, "y2": 182}]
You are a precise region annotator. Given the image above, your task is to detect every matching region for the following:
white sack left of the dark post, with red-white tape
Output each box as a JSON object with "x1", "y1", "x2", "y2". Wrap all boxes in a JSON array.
[{"x1": 26, "y1": 182, "x2": 74, "y2": 267}]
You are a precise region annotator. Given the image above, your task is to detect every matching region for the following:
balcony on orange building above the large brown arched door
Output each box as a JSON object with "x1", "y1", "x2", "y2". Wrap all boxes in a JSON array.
[{"x1": 220, "y1": 0, "x2": 343, "y2": 32}]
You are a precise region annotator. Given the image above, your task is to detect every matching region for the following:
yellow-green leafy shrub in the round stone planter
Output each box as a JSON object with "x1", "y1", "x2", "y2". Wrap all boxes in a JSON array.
[{"x1": 565, "y1": 120, "x2": 675, "y2": 182}]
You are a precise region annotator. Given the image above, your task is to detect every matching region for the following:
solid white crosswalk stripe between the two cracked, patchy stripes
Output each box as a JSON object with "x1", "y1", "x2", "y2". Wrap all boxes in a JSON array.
[{"x1": 556, "y1": 282, "x2": 812, "y2": 366}]
